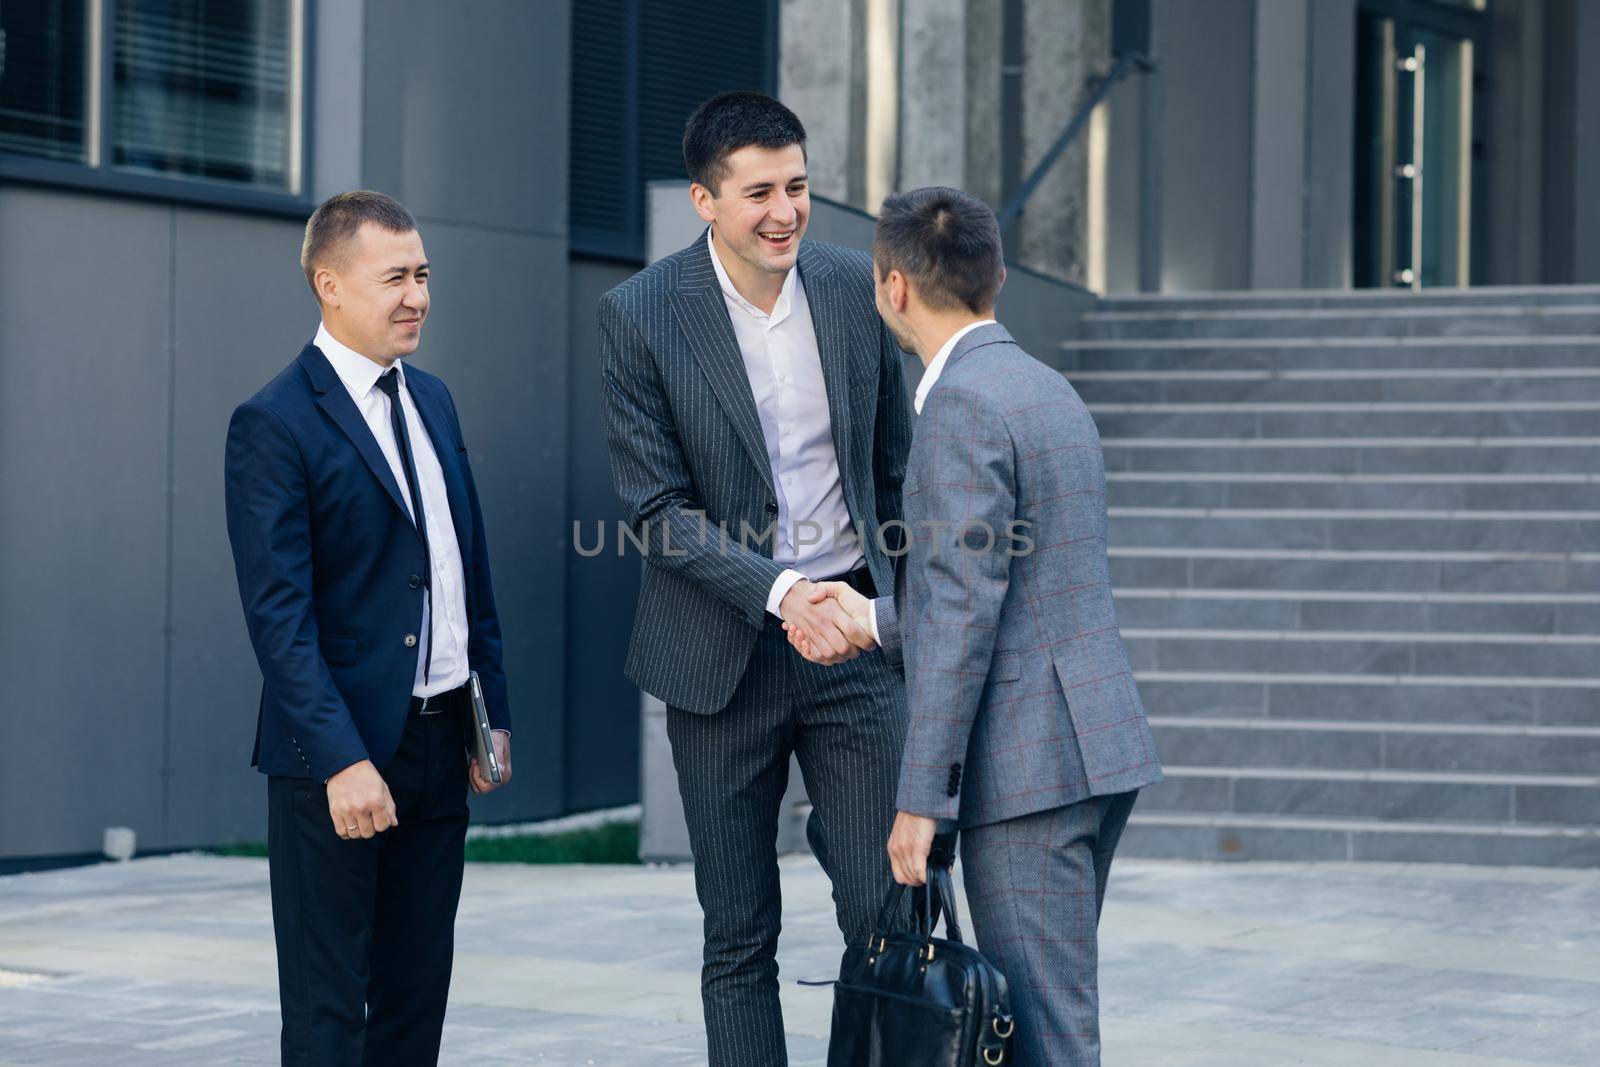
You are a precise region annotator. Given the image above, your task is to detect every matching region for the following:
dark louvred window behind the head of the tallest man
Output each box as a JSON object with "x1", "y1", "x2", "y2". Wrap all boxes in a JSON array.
[{"x1": 568, "y1": 0, "x2": 778, "y2": 261}]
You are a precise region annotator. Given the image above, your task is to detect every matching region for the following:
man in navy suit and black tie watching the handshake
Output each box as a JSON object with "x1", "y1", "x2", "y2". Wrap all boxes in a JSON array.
[{"x1": 227, "y1": 192, "x2": 510, "y2": 1067}]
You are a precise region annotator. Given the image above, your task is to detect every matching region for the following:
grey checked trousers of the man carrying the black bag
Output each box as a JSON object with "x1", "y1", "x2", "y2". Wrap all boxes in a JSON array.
[{"x1": 962, "y1": 790, "x2": 1139, "y2": 1067}]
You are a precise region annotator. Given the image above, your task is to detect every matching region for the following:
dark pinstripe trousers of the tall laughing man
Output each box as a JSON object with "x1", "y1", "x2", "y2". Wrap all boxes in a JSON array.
[{"x1": 667, "y1": 619, "x2": 906, "y2": 1067}]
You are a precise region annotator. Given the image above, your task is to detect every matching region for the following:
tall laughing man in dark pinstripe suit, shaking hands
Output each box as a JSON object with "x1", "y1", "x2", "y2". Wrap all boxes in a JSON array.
[{"x1": 600, "y1": 93, "x2": 910, "y2": 1067}]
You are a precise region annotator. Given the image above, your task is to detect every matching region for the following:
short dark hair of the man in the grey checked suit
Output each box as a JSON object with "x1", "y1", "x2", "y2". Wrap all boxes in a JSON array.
[{"x1": 872, "y1": 186, "x2": 1005, "y2": 314}]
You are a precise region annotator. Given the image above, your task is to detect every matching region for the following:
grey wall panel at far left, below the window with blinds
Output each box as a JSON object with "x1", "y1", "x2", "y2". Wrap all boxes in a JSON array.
[{"x1": 0, "y1": 189, "x2": 171, "y2": 856}]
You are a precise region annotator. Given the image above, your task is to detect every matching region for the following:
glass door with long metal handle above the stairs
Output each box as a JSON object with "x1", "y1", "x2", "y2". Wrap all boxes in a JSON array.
[{"x1": 1354, "y1": 3, "x2": 1483, "y2": 290}]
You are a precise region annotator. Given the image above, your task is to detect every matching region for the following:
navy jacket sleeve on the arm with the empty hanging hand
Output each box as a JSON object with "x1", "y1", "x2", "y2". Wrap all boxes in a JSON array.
[{"x1": 224, "y1": 403, "x2": 366, "y2": 781}]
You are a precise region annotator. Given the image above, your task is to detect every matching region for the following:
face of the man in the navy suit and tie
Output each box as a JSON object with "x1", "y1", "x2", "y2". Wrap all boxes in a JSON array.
[{"x1": 314, "y1": 222, "x2": 429, "y2": 366}]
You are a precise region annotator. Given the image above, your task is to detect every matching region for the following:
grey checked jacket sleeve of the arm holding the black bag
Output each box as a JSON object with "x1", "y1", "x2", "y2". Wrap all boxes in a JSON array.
[{"x1": 896, "y1": 386, "x2": 1016, "y2": 819}]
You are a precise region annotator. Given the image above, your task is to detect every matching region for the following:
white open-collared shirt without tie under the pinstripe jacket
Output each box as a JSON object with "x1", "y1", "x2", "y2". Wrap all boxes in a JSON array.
[{"x1": 706, "y1": 232, "x2": 864, "y2": 617}]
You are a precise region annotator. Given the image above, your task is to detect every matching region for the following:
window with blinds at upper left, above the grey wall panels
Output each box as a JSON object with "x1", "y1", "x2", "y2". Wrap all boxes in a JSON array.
[{"x1": 0, "y1": 0, "x2": 306, "y2": 195}]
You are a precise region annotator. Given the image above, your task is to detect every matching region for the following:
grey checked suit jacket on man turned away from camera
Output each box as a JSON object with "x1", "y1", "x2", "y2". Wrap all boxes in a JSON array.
[{"x1": 877, "y1": 325, "x2": 1162, "y2": 825}]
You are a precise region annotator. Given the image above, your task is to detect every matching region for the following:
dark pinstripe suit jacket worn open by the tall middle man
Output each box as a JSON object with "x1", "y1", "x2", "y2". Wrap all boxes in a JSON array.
[{"x1": 598, "y1": 234, "x2": 910, "y2": 715}]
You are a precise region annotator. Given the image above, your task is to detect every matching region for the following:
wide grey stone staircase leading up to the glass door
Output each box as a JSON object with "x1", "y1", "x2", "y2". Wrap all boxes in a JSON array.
[{"x1": 1058, "y1": 286, "x2": 1600, "y2": 867}]
